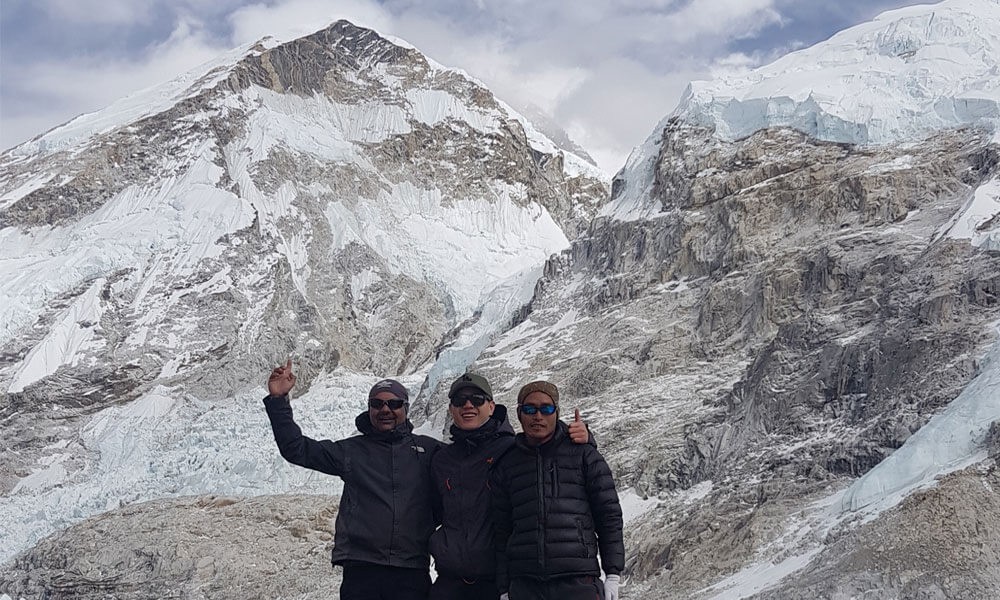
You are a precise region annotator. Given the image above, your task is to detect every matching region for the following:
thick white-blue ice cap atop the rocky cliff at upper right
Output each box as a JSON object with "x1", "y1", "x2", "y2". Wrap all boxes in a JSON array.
[{"x1": 674, "y1": 0, "x2": 1000, "y2": 144}]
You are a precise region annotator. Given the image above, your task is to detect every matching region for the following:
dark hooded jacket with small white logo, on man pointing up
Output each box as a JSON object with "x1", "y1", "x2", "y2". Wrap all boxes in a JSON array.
[{"x1": 264, "y1": 396, "x2": 440, "y2": 569}]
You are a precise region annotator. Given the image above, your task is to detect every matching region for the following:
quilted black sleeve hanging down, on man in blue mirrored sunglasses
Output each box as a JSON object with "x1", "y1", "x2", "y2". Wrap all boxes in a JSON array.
[{"x1": 584, "y1": 447, "x2": 625, "y2": 575}]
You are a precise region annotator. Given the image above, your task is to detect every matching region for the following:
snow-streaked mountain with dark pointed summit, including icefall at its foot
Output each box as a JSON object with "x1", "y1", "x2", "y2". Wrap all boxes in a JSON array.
[{"x1": 0, "y1": 22, "x2": 608, "y2": 576}]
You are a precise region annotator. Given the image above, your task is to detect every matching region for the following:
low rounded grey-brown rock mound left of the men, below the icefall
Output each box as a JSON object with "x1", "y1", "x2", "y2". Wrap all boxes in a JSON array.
[{"x1": 0, "y1": 495, "x2": 340, "y2": 600}]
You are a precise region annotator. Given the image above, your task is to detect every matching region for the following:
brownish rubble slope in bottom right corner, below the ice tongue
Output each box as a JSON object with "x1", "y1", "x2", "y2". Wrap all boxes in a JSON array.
[{"x1": 753, "y1": 463, "x2": 1000, "y2": 600}]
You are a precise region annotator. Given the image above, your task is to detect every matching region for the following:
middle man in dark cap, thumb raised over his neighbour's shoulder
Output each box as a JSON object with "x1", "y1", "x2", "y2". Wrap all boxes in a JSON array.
[{"x1": 430, "y1": 373, "x2": 590, "y2": 600}]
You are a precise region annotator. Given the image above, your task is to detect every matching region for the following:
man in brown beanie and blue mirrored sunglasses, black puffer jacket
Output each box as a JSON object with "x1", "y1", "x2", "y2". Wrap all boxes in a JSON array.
[{"x1": 491, "y1": 381, "x2": 625, "y2": 600}]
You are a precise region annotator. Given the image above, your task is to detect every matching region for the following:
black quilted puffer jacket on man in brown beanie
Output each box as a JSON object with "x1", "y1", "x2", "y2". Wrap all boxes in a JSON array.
[{"x1": 491, "y1": 421, "x2": 625, "y2": 592}]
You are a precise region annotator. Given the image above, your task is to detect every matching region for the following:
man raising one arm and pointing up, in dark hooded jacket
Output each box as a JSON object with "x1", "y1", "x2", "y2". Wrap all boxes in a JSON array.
[{"x1": 264, "y1": 360, "x2": 439, "y2": 600}]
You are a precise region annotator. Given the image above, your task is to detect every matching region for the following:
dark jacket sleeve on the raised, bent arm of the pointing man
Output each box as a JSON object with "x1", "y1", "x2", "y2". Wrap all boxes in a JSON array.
[{"x1": 264, "y1": 396, "x2": 344, "y2": 476}]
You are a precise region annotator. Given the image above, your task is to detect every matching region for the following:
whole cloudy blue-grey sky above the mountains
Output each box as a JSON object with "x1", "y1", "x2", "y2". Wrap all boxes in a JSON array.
[{"x1": 0, "y1": 0, "x2": 917, "y2": 173}]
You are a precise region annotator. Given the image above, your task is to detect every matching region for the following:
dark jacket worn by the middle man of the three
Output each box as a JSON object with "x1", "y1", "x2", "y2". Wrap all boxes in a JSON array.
[{"x1": 431, "y1": 405, "x2": 514, "y2": 580}]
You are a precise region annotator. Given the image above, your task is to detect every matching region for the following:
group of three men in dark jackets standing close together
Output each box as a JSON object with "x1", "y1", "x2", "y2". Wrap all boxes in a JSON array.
[{"x1": 264, "y1": 361, "x2": 624, "y2": 600}]
